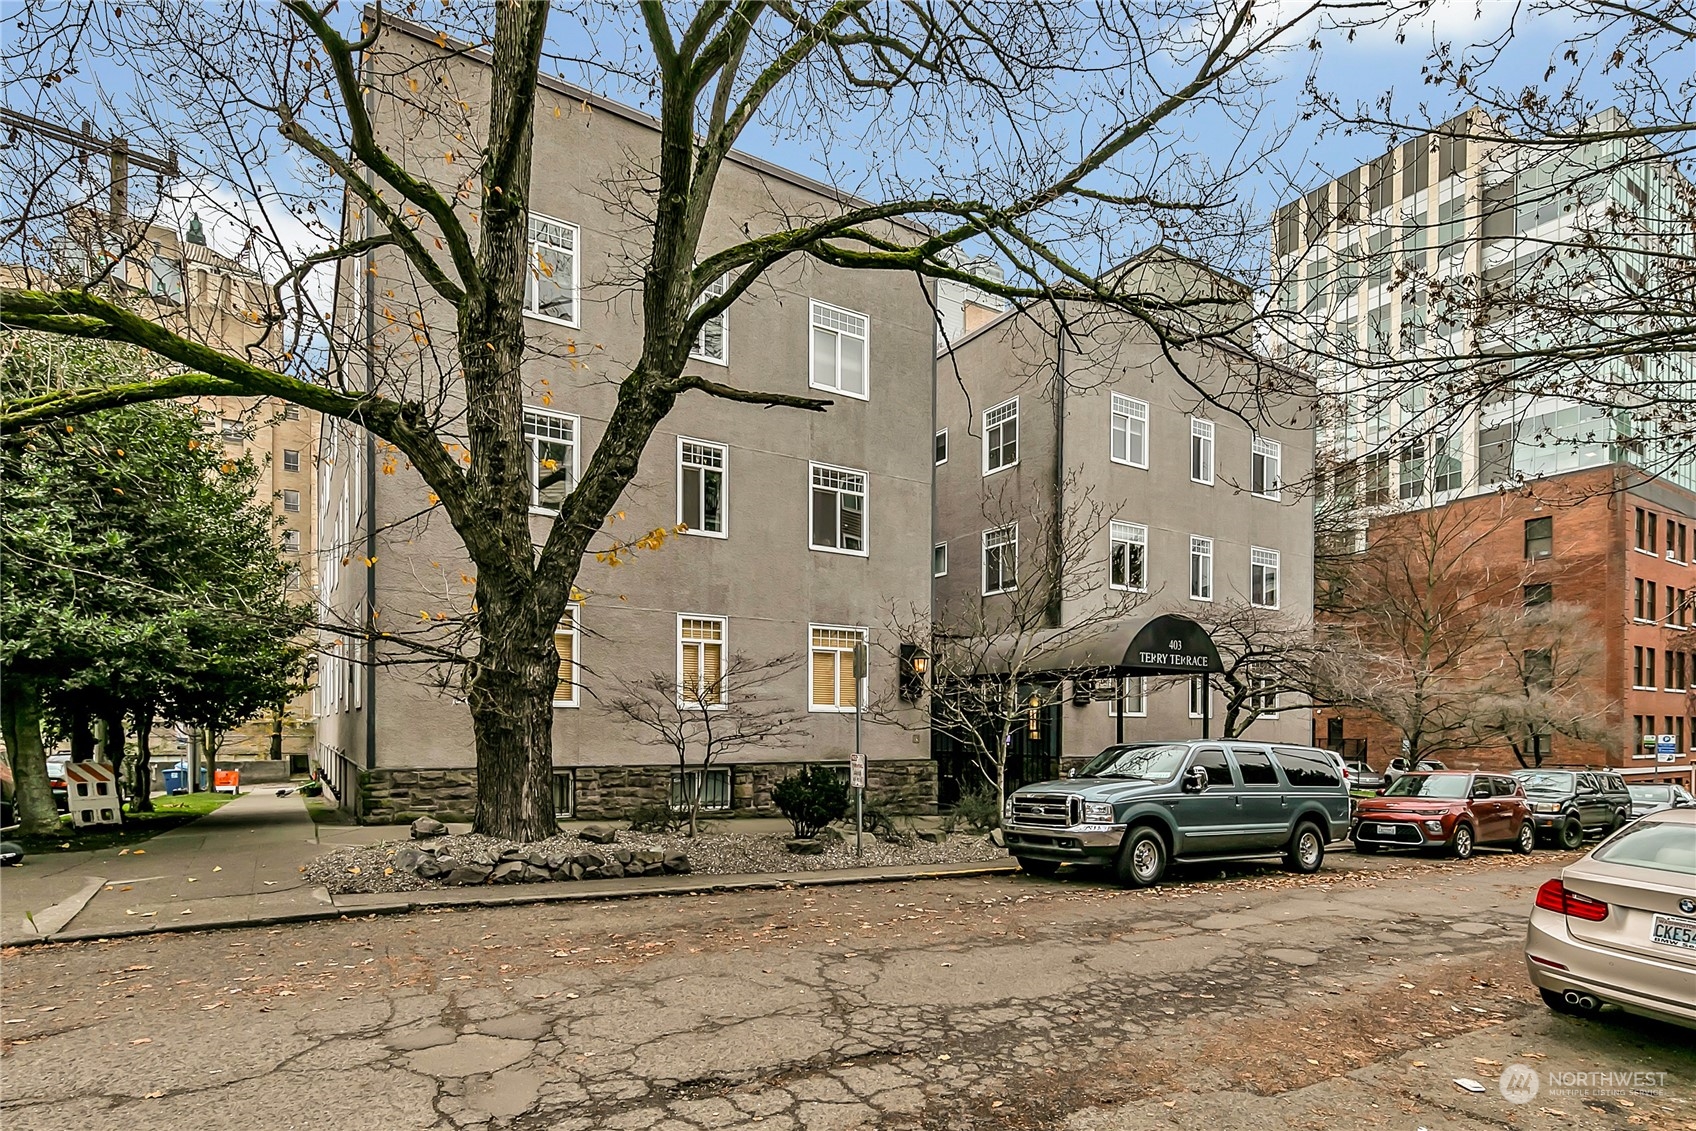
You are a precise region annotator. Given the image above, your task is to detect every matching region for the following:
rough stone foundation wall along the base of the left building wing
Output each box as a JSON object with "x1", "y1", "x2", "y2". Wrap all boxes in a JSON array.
[{"x1": 358, "y1": 760, "x2": 936, "y2": 824}]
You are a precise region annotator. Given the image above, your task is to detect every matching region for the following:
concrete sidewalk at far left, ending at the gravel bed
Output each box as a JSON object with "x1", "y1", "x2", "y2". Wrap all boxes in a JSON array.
[{"x1": 0, "y1": 790, "x2": 331, "y2": 944}]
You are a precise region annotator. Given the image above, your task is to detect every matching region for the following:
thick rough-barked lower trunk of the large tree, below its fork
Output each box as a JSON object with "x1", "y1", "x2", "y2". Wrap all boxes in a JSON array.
[{"x1": 470, "y1": 602, "x2": 560, "y2": 841}]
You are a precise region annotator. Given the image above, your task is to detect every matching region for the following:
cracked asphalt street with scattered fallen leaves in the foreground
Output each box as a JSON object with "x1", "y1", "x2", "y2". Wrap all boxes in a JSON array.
[{"x1": 0, "y1": 853, "x2": 1696, "y2": 1131}]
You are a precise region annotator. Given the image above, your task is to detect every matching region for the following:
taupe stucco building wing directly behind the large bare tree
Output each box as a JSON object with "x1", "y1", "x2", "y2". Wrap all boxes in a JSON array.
[{"x1": 315, "y1": 31, "x2": 934, "y2": 819}]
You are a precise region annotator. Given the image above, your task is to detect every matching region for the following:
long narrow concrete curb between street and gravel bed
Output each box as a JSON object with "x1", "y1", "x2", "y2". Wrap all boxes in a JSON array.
[{"x1": 5, "y1": 856, "x2": 1019, "y2": 948}]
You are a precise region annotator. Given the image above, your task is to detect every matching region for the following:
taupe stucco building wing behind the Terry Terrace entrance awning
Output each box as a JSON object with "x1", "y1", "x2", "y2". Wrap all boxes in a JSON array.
[{"x1": 933, "y1": 249, "x2": 1313, "y2": 800}]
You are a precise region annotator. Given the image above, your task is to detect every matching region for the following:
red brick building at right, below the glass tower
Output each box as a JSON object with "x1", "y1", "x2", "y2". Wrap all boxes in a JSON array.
[{"x1": 1314, "y1": 465, "x2": 1696, "y2": 788}]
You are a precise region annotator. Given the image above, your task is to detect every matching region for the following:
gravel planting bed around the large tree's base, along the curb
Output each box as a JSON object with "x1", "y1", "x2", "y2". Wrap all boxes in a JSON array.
[{"x1": 302, "y1": 829, "x2": 1006, "y2": 895}]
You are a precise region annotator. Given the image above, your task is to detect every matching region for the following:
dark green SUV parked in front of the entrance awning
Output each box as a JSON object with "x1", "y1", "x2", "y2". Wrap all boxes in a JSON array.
[{"x1": 1002, "y1": 739, "x2": 1350, "y2": 887}]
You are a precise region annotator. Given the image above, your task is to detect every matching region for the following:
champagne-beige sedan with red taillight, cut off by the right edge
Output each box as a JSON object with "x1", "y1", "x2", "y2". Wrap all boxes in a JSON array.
[{"x1": 1525, "y1": 809, "x2": 1696, "y2": 1028}]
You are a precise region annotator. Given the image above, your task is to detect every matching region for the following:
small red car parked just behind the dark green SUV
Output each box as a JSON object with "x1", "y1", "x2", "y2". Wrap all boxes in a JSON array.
[{"x1": 1352, "y1": 770, "x2": 1537, "y2": 860}]
